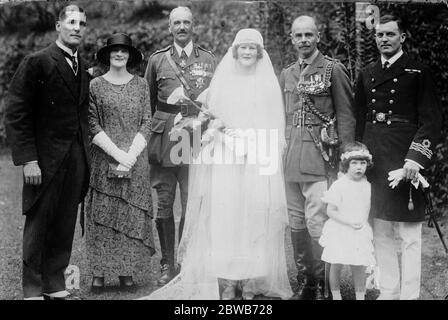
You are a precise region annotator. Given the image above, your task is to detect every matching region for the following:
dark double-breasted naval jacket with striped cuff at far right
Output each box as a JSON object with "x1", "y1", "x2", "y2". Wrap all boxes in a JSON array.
[{"x1": 355, "y1": 54, "x2": 441, "y2": 222}]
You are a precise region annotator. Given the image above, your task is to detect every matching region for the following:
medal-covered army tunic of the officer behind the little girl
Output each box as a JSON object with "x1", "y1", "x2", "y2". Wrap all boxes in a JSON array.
[{"x1": 280, "y1": 52, "x2": 355, "y2": 182}]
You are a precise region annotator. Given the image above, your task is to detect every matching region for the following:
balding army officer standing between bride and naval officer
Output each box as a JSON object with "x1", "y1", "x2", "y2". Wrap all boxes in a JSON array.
[{"x1": 280, "y1": 16, "x2": 355, "y2": 299}]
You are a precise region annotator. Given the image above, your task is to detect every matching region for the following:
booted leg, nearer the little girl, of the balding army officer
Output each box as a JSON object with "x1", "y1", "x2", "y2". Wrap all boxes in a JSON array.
[{"x1": 301, "y1": 180, "x2": 328, "y2": 299}]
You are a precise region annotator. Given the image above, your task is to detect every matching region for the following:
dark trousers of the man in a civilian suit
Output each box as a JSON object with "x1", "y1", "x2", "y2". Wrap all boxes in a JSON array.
[{"x1": 22, "y1": 139, "x2": 88, "y2": 298}]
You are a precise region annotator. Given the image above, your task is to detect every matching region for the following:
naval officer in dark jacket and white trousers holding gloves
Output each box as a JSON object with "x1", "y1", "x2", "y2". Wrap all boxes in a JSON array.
[{"x1": 355, "y1": 15, "x2": 441, "y2": 300}]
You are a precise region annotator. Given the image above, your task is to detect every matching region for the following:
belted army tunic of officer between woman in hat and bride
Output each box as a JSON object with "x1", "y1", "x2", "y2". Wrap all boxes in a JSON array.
[{"x1": 145, "y1": 44, "x2": 215, "y2": 167}]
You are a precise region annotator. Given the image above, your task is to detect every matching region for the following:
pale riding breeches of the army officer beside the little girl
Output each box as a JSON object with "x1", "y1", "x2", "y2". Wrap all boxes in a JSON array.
[{"x1": 286, "y1": 180, "x2": 328, "y2": 241}]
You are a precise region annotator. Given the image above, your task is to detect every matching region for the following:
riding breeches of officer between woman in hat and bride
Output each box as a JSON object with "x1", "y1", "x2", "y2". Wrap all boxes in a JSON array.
[{"x1": 150, "y1": 165, "x2": 188, "y2": 219}]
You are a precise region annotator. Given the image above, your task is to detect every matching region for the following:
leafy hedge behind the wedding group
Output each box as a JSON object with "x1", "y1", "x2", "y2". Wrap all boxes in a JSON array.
[{"x1": 0, "y1": 0, "x2": 448, "y2": 214}]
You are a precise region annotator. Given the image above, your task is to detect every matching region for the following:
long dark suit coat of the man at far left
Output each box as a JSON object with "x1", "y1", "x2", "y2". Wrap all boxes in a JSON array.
[{"x1": 5, "y1": 43, "x2": 89, "y2": 214}]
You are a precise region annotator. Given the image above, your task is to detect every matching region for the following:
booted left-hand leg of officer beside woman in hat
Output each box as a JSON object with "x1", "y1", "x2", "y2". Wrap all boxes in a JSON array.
[{"x1": 150, "y1": 165, "x2": 177, "y2": 286}]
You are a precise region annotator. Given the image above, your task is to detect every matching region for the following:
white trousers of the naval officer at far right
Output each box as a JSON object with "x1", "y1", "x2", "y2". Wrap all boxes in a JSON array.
[{"x1": 373, "y1": 219, "x2": 422, "y2": 300}]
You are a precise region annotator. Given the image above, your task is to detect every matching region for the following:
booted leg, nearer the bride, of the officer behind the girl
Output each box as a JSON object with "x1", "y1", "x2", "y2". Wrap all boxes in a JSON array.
[{"x1": 285, "y1": 182, "x2": 314, "y2": 300}]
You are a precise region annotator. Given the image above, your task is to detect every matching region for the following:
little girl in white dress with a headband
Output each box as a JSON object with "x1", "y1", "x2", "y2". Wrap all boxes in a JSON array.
[{"x1": 319, "y1": 142, "x2": 375, "y2": 300}]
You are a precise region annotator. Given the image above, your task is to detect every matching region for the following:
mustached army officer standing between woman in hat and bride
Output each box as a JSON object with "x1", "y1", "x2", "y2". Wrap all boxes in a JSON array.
[{"x1": 145, "y1": 7, "x2": 215, "y2": 285}]
